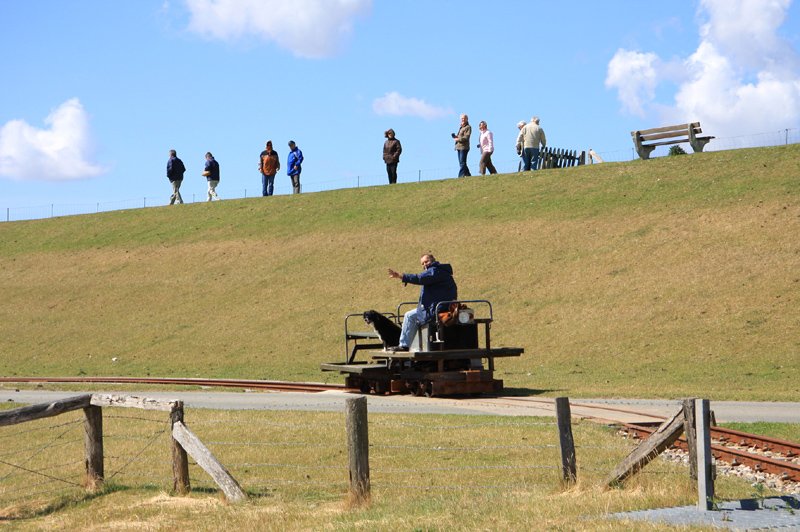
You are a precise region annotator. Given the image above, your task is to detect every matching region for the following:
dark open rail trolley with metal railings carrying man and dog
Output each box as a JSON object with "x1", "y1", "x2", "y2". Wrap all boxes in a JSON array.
[{"x1": 321, "y1": 299, "x2": 524, "y2": 397}]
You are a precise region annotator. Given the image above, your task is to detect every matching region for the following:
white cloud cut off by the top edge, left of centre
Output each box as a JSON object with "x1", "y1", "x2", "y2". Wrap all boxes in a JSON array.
[{"x1": 186, "y1": 0, "x2": 372, "y2": 58}]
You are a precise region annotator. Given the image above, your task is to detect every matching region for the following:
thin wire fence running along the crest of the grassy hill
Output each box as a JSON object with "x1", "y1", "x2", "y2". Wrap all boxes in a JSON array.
[{"x1": 0, "y1": 128, "x2": 800, "y2": 222}]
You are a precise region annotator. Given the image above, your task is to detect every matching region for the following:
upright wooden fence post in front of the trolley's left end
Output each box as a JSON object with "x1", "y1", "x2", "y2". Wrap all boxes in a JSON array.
[{"x1": 345, "y1": 397, "x2": 370, "y2": 505}]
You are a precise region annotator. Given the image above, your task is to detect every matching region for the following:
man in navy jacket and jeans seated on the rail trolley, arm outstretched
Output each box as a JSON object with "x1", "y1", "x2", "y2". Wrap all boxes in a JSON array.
[{"x1": 389, "y1": 253, "x2": 458, "y2": 351}]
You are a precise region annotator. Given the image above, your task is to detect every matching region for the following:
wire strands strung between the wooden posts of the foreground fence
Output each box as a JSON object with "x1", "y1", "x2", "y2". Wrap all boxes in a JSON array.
[{"x1": 0, "y1": 394, "x2": 685, "y2": 519}]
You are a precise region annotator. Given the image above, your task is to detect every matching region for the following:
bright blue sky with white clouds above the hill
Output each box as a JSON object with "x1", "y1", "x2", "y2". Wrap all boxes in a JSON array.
[{"x1": 0, "y1": 0, "x2": 800, "y2": 214}]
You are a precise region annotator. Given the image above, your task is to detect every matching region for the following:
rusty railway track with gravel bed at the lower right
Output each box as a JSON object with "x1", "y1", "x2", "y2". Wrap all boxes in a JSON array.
[{"x1": 623, "y1": 423, "x2": 800, "y2": 482}]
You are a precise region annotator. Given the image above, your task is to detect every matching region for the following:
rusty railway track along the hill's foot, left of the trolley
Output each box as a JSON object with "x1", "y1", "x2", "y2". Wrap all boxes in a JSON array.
[{"x1": 0, "y1": 377, "x2": 346, "y2": 392}]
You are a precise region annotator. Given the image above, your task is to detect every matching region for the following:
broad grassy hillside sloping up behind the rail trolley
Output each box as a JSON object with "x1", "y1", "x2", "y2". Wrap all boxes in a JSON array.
[{"x1": 0, "y1": 145, "x2": 800, "y2": 400}]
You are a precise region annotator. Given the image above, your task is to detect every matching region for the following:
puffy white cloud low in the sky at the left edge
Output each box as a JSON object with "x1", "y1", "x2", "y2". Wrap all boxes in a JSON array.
[{"x1": 0, "y1": 98, "x2": 105, "y2": 181}]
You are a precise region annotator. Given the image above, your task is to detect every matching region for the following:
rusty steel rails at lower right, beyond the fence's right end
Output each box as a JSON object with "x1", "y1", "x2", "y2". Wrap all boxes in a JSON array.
[{"x1": 623, "y1": 423, "x2": 800, "y2": 482}]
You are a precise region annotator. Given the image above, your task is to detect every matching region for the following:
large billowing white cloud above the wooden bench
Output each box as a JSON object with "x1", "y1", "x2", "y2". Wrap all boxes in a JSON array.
[{"x1": 606, "y1": 0, "x2": 800, "y2": 137}]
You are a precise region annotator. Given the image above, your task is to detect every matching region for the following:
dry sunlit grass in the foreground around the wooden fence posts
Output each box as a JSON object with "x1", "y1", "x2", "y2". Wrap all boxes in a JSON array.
[{"x1": 0, "y1": 408, "x2": 764, "y2": 530}]
